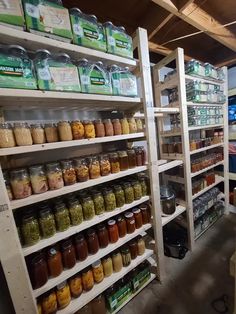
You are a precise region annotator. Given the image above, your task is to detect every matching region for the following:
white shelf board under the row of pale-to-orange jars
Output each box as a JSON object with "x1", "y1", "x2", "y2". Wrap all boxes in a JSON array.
[{"x1": 0, "y1": 132, "x2": 145, "y2": 156}]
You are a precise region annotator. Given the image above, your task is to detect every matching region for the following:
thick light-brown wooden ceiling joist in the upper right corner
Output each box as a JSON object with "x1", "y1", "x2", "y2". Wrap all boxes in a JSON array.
[{"x1": 152, "y1": 0, "x2": 236, "y2": 51}]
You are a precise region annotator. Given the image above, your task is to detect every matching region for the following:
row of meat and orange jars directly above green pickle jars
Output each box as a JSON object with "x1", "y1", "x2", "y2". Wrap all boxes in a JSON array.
[{"x1": 4, "y1": 146, "x2": 146, "y2": 200}]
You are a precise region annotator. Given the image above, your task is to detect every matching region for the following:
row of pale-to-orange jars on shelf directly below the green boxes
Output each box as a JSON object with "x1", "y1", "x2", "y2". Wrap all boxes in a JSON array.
[{"x1": 0, "y1": 118, "x2": 143, "y2": 148}]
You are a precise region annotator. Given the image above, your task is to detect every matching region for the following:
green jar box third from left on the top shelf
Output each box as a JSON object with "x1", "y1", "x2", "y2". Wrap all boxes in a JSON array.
[{"x1": 69, "y1": 8, "x2": 107, "y2": 51}]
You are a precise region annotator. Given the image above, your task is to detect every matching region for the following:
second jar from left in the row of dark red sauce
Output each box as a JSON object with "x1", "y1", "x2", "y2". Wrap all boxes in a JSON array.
[{"x1": 47, "y1": 247, "x2": 63, "y2": 277}]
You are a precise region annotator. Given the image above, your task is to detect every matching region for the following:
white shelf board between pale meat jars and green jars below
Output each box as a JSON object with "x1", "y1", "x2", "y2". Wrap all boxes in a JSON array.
[{"x1": 10, "y1": 166, "x2": 148, "y2": 209}]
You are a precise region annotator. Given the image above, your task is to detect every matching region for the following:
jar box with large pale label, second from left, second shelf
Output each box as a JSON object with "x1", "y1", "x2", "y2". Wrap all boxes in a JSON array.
[{"x1": 34, "y1": 50, "x2": 81, "y2": 92}]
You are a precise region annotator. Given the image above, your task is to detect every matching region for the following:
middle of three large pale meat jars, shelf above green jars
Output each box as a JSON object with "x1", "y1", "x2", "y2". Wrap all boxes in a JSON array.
[{"x1": 29, "y1": 165, "x2": 48, "y2": 194}]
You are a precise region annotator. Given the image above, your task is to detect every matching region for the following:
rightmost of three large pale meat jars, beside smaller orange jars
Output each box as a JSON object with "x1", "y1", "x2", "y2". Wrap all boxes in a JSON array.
[{"x1": 46, "y1": 162, "x2": 64, "y2": 190}]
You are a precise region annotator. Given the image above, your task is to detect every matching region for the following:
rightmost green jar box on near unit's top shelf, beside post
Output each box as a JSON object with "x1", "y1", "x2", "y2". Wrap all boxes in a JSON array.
[{"x1": 104, "y1": 22, "x2": 133, "y2": 58}]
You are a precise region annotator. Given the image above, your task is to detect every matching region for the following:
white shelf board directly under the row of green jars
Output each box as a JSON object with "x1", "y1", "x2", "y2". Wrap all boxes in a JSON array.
[{"x1": 22, "y1": 196, "x2": 150, "y2": 256}]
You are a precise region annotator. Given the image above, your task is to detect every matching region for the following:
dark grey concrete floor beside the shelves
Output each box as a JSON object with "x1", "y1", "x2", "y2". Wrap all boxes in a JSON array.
[{"x1": 119, "y1": 214, "x2": 236, "y2": 314}]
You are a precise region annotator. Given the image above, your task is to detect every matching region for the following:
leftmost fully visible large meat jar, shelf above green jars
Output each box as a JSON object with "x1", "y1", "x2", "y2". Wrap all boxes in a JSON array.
[{"x1": 10, "y1": 169, "x2": 32, "y2": 199}]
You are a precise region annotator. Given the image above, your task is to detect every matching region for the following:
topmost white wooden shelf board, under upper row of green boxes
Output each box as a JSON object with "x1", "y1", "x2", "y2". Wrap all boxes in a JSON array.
[{"x1": 0, "y1": 25, "x2": 137, "y2": 67}]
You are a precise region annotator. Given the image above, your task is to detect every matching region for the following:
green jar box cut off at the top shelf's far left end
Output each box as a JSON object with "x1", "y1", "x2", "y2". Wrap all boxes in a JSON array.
[{"x1": 0, "y1": 0, "x2": 24, "y2": 29}]
